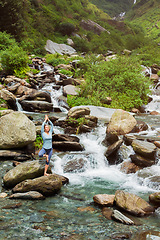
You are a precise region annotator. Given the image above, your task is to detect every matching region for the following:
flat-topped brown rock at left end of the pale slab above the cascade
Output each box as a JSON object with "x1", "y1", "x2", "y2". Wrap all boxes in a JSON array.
[{"x1": 68, "y1": 107, "x2": 90, "y2": 119}]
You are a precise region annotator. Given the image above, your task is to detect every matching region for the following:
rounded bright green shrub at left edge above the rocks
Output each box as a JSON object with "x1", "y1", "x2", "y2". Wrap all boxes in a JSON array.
[{"x1": 1, "y1": 45, "x2": 28, "y2": 74}]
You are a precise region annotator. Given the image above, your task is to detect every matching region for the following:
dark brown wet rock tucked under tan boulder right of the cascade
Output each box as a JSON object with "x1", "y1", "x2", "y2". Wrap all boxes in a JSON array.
[{"x1": 130, "y1": 154, "x2": 155, "y2": 167}]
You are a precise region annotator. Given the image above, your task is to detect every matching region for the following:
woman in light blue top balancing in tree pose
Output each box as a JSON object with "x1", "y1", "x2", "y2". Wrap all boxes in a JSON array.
[{"x1": 38, "y1": 115, "x2": 53, "y2": 175}]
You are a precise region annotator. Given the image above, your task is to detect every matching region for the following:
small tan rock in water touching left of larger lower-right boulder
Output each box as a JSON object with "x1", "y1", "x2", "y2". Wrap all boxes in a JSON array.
[{"x1": 93, "y1": 194, "x2": 115, "y2": 206}]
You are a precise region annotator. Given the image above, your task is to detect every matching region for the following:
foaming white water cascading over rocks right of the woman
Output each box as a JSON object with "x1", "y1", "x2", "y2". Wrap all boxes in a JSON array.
[{"x1": 52, "y1": 121, "x2": 160, "y2": 194}]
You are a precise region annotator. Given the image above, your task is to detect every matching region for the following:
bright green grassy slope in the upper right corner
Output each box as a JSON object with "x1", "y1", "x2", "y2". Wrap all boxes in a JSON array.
[{"x1": 127, "y1": 0, "x2": 160, "y2": 43}]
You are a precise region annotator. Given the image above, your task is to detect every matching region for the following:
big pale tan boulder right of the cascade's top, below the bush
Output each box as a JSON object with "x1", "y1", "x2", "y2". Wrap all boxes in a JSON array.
[{"x1": 107, "y1": 109, "x2": 137, "y2": 135}]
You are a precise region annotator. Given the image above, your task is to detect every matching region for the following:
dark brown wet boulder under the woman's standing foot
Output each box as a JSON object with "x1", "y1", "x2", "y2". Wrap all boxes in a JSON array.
[{"x1": 13, "y1": 174, "x2": 62, "y2": 196}]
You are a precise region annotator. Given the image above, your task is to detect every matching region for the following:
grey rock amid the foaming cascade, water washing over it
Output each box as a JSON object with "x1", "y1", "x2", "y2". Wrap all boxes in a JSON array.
[{"x1": 63, "y1": 158, "x2": 86, "y2": 172}]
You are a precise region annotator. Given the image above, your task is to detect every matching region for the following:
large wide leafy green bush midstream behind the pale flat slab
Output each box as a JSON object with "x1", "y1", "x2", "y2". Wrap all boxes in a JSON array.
[{"x1": 68, "y1": 56, "x2": 150, "y2": 110}]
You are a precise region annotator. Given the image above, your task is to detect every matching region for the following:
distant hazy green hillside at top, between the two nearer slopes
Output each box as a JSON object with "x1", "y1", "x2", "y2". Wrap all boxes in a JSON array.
[{"x1": 91, "y1": 0, "x2": 134, "y2": 17}]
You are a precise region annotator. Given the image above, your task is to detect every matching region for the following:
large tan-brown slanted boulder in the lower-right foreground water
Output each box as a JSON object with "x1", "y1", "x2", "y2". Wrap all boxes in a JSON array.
[{"x1": 115, "y1": 190, "x2": 155, "y2": 217}]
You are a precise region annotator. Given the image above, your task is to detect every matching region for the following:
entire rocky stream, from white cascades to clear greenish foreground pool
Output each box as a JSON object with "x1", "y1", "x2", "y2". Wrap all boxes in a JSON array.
[{"x1": 0, "y1": 70, "x2": 160, "y2": 240}]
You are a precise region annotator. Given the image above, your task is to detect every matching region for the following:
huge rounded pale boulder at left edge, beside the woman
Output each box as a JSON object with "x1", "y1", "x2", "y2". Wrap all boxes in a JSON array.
[{"x1": 0, "y1": 112, "x2": 36, "y2": 149}]
